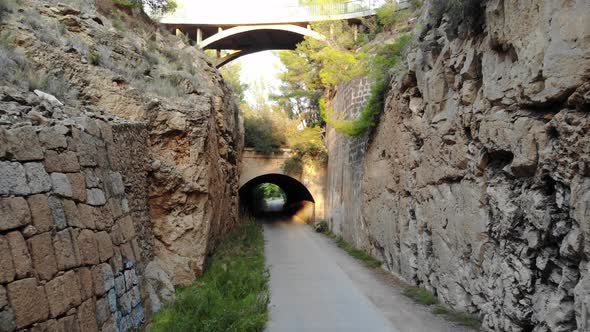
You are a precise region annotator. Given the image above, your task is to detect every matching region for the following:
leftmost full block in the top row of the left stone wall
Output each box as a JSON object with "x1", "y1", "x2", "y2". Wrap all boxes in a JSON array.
[{"x1": 8, "y1": 126, "x2": 43, "y2": 161}]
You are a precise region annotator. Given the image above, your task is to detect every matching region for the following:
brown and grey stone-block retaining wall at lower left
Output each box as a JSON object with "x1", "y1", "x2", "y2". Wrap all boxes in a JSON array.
[{"x1": 0, "y1": 89, "x2": 149, "y2": 331}]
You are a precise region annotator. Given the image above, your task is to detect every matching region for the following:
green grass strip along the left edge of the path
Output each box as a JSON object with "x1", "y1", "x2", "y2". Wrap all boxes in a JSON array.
[{"x1": 148, "y1": 220, "x2": 269, "y2": 332}]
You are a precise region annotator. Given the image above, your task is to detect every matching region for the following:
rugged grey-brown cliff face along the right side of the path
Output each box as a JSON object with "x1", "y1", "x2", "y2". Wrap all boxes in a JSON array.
[{"x1": 336, "y1": 0, "x2": 590, "y2": 331}]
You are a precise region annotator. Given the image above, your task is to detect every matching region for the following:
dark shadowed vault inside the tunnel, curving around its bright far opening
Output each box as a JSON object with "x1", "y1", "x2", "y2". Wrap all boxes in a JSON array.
[{"x1": 239, "y1": 173, "x2": 315, "y2": 223}]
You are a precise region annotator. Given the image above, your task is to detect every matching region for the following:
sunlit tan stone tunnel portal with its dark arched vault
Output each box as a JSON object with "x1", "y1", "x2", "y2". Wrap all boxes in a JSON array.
[{"x1": 240, "y1": 148, "x2": 326, "y2": 223}]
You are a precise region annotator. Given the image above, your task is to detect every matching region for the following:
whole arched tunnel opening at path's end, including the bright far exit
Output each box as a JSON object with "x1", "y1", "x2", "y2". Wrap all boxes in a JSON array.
[{"x1": 239, "y1": 174, "x2": 315, "y2": 223}]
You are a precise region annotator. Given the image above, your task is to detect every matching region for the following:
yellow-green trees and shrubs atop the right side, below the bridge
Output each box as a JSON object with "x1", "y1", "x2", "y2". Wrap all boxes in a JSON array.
[{"x1": 279, "y1": 1, "x2": 421, "y2": 136}]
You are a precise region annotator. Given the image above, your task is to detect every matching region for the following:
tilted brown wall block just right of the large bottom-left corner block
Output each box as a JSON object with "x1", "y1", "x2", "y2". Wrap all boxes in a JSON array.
[{"x1": 45, "y1": 271, "x2": 82, "y2": 317}]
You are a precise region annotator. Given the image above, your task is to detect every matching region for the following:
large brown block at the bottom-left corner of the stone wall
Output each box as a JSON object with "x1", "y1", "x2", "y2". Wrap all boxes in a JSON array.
[{"x1": 8, "y1": 278, "x2": 49, "y2": 328}]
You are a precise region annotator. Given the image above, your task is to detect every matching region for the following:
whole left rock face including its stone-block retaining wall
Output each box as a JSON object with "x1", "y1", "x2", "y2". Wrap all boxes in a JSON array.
[{"x1": 0, "y1": 0, "x2": 242, "y2": 331}]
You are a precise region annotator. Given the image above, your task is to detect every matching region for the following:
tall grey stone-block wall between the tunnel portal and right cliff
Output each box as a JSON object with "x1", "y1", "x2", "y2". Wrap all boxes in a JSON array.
[{"x1": 325, "y1": 78, "x2": 371, "y2": 244}]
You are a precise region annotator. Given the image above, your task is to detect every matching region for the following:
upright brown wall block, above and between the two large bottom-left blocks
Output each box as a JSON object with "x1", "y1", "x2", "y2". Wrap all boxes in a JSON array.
[{"x1": 27, "y1": 233, "x2": 57, "y2": 280}]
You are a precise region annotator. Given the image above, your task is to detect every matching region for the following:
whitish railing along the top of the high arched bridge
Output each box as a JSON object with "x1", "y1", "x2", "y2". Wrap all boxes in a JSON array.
[{"x1": 162, "y1": 0, "x2": 409, "y2": 25}]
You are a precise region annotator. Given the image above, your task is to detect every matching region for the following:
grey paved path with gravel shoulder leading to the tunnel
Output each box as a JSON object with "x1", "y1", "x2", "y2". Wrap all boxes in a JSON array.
[{"x1": 264, "y1": 222, "x2": 478, "y2": 332}]
